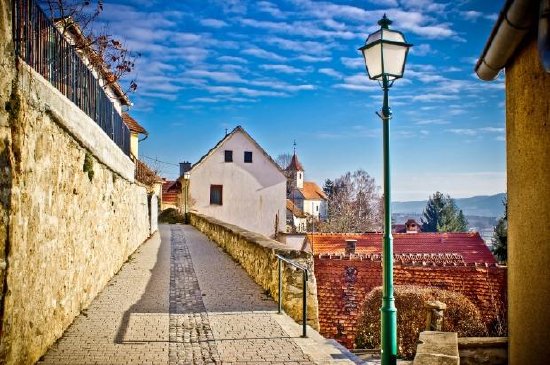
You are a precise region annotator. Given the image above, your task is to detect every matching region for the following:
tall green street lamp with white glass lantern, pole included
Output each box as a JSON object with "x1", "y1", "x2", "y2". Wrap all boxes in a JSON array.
[{"x1": 359, "y1": 14, "x2": 412, "y2": 365}]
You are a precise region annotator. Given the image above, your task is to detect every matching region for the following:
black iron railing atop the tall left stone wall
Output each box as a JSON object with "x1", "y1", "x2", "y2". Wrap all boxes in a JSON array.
[{"x1": 13, "y1": 0, "x2": 130, "y2": 155}]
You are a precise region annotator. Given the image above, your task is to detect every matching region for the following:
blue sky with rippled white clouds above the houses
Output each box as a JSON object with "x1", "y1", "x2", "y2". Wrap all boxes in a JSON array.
[{"x1": 98, "y1": 0, "x2": 505, "y2": 200}]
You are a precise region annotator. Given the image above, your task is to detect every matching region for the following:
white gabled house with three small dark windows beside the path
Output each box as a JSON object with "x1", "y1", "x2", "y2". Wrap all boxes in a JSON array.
[{"x1": 184, "y1": 126, "x2": 286, "y2": 237}]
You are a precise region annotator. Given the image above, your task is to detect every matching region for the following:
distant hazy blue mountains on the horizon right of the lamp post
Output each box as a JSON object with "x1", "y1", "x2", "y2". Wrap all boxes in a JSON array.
[{"x1": 392, "y1": 193, "x2": 506, "y2": 217}]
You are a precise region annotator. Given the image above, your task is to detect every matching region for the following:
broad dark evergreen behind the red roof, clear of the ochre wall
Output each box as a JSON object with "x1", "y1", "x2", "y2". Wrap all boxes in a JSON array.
[{"x1": 421, "y1": 191, "x2": 468, "y2": 232}]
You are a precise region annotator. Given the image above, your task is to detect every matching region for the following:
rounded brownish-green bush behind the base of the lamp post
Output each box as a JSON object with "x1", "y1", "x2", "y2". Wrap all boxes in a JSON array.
[{"x1": 355, "y1": 285, "x2": 487, "y2": 359}]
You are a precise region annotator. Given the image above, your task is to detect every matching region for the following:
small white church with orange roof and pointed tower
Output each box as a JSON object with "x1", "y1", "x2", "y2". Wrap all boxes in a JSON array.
[{"x1": 286, "y1": 152, "x2": 328, "y2": 221}]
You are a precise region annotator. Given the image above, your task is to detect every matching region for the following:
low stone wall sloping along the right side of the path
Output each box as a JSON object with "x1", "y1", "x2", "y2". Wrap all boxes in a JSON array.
[{"x1": 189, "y1": 213, "x2": 319, "y2": 330}]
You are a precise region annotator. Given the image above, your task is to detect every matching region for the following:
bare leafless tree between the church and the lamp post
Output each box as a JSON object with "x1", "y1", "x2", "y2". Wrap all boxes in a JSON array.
[{"x1": 320, "y1": 170, "x2": 383, "y2": 232}]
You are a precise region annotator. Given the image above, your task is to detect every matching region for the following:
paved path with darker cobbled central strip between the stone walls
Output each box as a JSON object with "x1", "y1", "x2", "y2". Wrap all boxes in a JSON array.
[{"x1": 39, "y1": 225, "x2": 366, "y2": 365}]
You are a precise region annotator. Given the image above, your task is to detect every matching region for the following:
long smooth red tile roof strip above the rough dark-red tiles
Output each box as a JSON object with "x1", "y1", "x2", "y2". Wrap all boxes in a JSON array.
[{"x1": 307, "y1": 232, "x2": 496, "y2": 264}]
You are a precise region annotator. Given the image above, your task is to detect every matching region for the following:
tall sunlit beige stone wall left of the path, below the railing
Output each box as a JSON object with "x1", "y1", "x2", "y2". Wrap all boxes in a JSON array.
[{"x1": 0, "y1": 1, "x2": 150, "y2": 364}]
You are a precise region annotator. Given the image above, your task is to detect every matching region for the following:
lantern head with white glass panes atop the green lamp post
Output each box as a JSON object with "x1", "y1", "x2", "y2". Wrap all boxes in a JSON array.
[{"x1": 359, "y1": 14, "x2": 412, "y2": 81}]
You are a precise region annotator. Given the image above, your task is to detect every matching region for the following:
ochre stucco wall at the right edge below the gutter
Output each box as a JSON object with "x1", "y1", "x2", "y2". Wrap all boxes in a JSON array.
[{"x1": 506, "y1": 38, "x2": 550, "y2": 364}]
